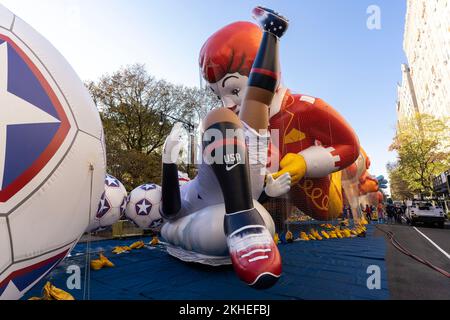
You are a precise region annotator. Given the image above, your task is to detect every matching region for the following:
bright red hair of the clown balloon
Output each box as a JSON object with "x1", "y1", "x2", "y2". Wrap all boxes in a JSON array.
[{"x1": 199, "y1": 22, "x2": 262, "y2": 83}]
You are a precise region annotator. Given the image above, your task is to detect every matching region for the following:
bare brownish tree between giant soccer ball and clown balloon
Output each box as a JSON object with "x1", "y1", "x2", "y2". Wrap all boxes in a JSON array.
[{"x1": 86, "y1": 64, "x2": 218, "y2": 190}]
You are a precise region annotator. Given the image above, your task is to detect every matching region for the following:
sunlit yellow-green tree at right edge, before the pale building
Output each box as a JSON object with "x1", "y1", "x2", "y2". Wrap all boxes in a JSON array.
[{"x1": 390, "y1": 114, "x2": 450, "y2": 196}]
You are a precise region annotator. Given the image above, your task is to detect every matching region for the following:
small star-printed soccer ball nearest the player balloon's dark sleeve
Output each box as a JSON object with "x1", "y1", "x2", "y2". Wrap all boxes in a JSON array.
[{"x1": 126, "y1": 184, "x2": 162, "y2": 229}]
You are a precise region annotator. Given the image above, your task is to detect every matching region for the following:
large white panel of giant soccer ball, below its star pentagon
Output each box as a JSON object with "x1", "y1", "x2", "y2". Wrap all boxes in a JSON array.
[{"x1": 9, "y1": 132, "x2": 105, "y2": 260}]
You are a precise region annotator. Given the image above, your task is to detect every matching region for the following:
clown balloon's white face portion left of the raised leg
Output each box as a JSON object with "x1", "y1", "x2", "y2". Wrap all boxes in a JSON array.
[{"x1": 209, "y1": 72, "x2": 248, "y2": 114}]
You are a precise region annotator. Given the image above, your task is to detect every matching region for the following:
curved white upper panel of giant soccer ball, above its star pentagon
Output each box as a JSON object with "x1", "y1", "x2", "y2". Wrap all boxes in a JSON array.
[{"x1": 13, "y1": 17, "x2": 102, "y2": 139}]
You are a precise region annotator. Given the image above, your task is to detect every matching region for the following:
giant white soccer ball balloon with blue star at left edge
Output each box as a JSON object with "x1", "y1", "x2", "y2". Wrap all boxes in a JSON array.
[{"x1": 0, "y1": 5, "x2": 105, "y2": 299}]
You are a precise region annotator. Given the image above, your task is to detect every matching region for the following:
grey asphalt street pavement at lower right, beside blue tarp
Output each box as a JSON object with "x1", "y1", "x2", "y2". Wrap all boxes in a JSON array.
[{"x1": 375, "y1": 224, "x2": 450, "y2": 300}]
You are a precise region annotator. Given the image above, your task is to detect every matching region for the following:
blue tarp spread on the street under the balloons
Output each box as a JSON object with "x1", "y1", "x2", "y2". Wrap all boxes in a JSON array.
[{"x1": 25, "y1": 226, "x2": 389, "y2": 300}]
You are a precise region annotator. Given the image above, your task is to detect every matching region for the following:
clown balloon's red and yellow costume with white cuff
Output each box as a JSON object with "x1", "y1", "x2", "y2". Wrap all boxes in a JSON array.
[{"x1": 269, "y1": 91, "x2": 359, "y2": 220}]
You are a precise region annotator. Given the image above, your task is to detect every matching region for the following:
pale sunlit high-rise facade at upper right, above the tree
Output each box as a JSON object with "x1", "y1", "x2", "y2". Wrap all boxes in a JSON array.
[{"x1": 397, "y1": 0, "x2": 450, "y2": 121}]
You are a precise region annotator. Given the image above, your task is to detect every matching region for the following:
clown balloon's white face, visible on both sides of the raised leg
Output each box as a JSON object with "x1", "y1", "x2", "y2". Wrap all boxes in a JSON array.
[{"x1": 208, "y1": 73, "x2": 286, "y2": 118}]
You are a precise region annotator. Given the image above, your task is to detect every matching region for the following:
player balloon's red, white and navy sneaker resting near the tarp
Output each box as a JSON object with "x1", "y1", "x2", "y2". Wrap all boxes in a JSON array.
[{"x1": 227, "y1": 225, "x2": 281, "y2": 289}]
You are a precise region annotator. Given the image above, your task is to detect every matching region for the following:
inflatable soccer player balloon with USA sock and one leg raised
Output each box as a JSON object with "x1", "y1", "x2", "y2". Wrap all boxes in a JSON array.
[{"x1": 160, "y1": 7, "x2": 296, "y2": 289}]
